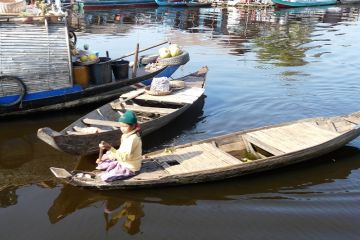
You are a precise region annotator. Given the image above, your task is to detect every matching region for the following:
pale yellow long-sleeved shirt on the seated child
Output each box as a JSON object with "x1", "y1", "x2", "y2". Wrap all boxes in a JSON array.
[{"x1": 109, "y1": 130, "x2": 142, "y2": 172}]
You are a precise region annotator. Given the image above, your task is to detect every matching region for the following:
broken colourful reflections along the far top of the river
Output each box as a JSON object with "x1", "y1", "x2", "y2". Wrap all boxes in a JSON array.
[{"x1": 73, "y1": 5, "x2": 359, "y2": 66}]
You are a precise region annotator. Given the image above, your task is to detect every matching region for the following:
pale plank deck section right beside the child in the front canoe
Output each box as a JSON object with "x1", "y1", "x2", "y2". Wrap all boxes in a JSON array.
[{"x1": 149, "y1": 143, "x2": 242, "y2": 174}]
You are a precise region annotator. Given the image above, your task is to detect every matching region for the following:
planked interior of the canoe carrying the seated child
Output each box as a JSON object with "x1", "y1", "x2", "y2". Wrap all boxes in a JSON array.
[{"x1": 135, "y1": 114, "x2": 360, "y2": 179}]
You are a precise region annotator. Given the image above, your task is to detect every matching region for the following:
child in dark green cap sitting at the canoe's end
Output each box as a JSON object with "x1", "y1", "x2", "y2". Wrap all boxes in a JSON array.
[{"x1": 96, "y1": 111, "x2": 142, "y2": 182}]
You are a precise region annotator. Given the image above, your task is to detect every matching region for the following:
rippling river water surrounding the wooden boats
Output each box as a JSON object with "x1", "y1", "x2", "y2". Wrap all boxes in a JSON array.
[{"x1": 0, "y1": 5, "x2": 360, "y2": 240}]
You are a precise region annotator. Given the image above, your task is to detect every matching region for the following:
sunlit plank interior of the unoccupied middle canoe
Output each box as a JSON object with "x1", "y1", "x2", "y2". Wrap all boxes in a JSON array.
[{"x1": 61, "y1": 76, "x2": 204, "y2": 135}]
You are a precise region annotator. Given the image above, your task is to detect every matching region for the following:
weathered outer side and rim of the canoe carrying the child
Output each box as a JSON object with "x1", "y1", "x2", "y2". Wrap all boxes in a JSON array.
[{"x1": 62, "y1": 114, "x2": 360, "y2": 190}]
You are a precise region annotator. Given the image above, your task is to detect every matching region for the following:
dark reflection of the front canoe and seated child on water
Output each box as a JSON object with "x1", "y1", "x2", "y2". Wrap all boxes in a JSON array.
[{"x1": 48, "y1": 146, "x2": 360, "y2": 234}]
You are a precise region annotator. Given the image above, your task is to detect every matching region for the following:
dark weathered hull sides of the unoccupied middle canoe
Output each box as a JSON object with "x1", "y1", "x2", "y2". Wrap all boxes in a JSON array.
[{"x1": 38, "y1": 68, "x2": 207, "y2": 155}]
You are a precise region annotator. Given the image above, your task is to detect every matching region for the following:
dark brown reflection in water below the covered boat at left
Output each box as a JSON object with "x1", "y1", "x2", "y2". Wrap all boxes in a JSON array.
[{"x1": 0, "y1": 113, "x2": 86, "y2": 208}]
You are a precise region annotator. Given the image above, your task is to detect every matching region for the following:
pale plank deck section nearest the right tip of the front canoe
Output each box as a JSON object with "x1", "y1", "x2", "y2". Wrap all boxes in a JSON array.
[{"x1": 244, "y1": 122, "x2": 340, "y2": 155}]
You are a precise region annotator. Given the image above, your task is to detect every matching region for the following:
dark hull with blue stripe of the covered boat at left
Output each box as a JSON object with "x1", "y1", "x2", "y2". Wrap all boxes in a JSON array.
[{"x1": 0, "y1": 66, "x2": 178, "y2": 117}]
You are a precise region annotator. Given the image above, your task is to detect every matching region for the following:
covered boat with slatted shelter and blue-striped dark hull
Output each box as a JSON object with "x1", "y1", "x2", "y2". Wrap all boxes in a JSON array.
[{"x1": 0, "y1": 15, "x2": 183, "y2": 118}]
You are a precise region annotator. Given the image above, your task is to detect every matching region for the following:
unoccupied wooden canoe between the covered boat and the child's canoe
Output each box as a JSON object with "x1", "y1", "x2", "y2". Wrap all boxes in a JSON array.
[{"x1": 37, "y1": 67, "x2": 208, "y2": 155}]
